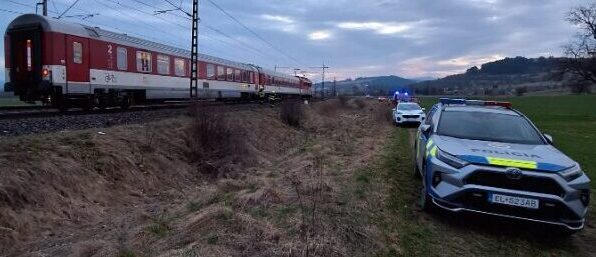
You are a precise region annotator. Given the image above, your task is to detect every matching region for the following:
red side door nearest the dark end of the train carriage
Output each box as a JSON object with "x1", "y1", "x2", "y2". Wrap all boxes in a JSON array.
[{"x1": 66, "y1": 36, "x2": 91, "y2": 94}]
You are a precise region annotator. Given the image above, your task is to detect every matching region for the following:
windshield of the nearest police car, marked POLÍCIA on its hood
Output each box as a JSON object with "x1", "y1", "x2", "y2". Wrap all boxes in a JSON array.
[{"x1": 437, "y1": 111, "x2": 544, "y2": 145}]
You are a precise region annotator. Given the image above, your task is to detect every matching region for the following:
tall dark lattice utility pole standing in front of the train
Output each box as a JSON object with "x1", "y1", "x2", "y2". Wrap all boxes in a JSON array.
[{"x1": 190, "y1": 0, "x2": 199, "y2": 98}]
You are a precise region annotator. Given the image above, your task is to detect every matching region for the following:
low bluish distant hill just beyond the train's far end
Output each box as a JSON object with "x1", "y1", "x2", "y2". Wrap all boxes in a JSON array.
[{"x1": 315, "y1": 75, "x2": 415, "y2": 95}]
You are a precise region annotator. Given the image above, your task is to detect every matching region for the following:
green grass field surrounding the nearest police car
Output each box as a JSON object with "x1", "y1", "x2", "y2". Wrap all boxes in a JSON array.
[{"x1": 382, "y1": 95, "x2": 596, "y2": 256}]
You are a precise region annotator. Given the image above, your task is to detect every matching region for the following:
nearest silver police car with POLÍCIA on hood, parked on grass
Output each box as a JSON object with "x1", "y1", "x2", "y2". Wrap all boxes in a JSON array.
[{"x1": 414, "y1": 99, "x2": 590, "y2": 232}]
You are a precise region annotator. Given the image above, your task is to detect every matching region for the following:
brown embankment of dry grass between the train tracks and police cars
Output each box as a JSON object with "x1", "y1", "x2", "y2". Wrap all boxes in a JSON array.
[{"x1": 0, "y1": 100, "x2": 390, "y2": 256}]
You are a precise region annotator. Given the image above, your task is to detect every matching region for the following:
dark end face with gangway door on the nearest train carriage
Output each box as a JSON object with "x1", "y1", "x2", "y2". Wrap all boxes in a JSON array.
[{"x1": 7, "y1": 27, "x2": 42, "y2": 101}]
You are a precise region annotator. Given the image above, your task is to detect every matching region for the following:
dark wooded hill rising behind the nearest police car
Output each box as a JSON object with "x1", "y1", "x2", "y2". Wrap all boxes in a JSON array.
[{"x1": 412, "y1": 56, "x2": 565, "y2": 95}]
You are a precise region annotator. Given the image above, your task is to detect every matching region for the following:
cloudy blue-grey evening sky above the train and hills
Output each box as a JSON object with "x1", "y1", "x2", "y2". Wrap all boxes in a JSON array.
[{"x1": 0, "y1": 0, "x2": 594, "y2": 80}]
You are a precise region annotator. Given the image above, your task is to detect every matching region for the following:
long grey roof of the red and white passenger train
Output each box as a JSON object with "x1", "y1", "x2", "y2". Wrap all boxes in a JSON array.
[{"x1": 6, "y1": 14, "x2": 256, "y2": 70}]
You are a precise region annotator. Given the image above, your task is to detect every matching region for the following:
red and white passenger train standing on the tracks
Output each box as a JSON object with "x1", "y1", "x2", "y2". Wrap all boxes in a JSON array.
[{"x1": 4, "y1": 14, "x2": 312, "y2": 109}]
